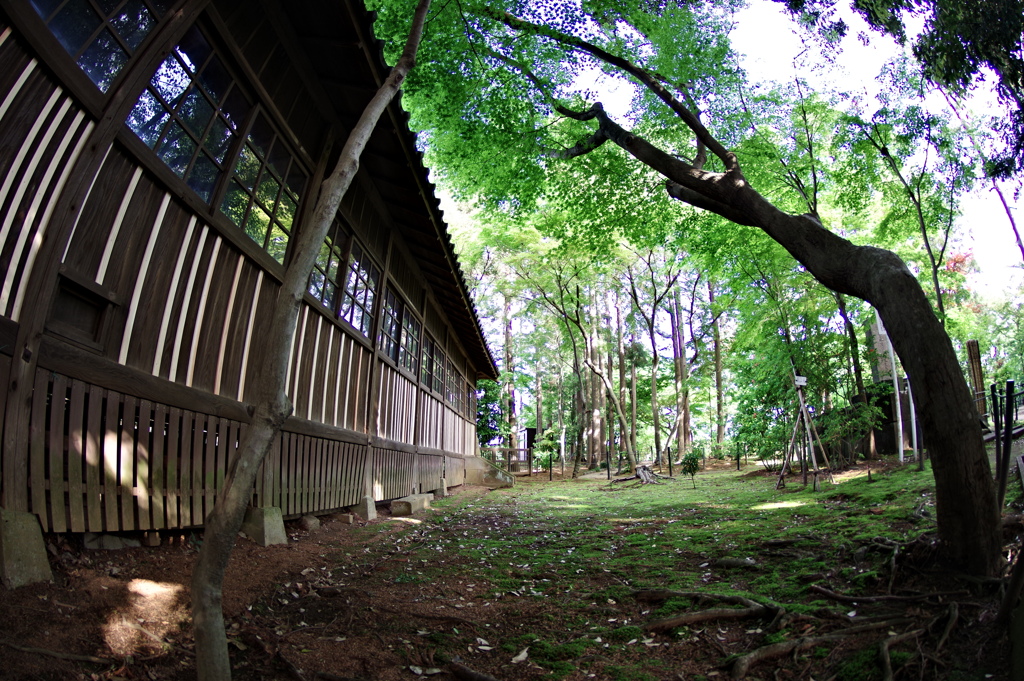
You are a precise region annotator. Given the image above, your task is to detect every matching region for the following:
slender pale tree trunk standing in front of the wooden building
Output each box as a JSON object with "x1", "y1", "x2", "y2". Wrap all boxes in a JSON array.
[{"x1": 191, "y1": 0, "x2": 430, "y2": 681}]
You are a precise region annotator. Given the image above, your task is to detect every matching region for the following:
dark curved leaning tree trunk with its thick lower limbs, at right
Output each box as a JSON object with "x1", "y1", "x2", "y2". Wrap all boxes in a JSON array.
[{"x1": 588, "y1": 107, "x2": 1000, "y2": 576}]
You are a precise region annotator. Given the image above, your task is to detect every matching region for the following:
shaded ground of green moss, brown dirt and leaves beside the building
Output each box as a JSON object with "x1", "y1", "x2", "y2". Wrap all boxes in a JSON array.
[{"x1": 6, "y1": 461, "x2": 1021, "y2": 681}]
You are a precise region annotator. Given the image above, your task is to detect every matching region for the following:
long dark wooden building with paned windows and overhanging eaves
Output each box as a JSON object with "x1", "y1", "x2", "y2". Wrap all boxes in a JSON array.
[{"x1": 0, "y1": 0, "x2": 496, "y2": 561}]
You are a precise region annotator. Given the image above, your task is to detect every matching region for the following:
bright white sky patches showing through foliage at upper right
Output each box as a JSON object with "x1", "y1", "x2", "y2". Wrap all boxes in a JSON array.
[{"x1": 730, "y1": 0, "x2": 1024, "y2": 297}]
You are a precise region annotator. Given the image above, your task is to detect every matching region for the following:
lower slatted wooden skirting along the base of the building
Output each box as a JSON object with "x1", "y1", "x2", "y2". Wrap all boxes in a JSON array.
[{"x1": 18, "y1": 365, "x2": 475, "y2": 531}]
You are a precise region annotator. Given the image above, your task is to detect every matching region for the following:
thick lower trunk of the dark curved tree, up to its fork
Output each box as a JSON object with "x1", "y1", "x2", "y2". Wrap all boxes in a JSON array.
[{"x1": 737, "y1": 193, "x2": 999, "y2": 574}]
